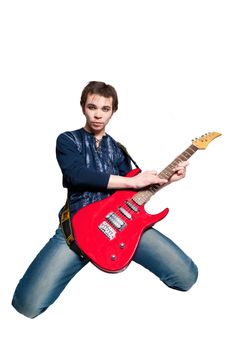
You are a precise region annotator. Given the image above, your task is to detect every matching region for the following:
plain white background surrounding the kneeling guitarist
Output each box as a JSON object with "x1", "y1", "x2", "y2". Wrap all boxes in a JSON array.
[{"x1": 0, "y1": 0, "x2": 233, "y2": 350}]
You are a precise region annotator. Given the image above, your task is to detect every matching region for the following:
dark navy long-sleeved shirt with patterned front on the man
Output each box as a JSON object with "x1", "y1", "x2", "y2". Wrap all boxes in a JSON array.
[{"x1": 56, "y1": 128, "x2": 131, "y2": 216}]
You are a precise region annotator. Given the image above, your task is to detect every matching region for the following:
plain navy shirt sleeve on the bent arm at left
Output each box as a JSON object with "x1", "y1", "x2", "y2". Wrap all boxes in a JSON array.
[{"x1": 56, "y1": 133, "x2": 110, "y2": 190}]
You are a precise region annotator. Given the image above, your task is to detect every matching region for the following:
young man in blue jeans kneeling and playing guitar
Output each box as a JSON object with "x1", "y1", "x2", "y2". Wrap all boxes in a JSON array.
[{"x1": 12, "y1": 81, "x2": 198, "y2": 318}]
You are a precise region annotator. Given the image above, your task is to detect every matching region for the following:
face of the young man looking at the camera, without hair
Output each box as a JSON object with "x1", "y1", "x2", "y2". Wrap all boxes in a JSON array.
[{"x1": 84, "y1": 94, "x2": 113, "y2": 134}]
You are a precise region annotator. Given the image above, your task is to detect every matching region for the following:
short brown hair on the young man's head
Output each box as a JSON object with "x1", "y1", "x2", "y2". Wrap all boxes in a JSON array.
[{"x1": 80, "y1": 81, "x2": 118, "y2": 112}]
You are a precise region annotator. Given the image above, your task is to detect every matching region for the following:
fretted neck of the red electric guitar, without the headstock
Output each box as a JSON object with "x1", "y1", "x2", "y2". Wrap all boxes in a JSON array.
[{"x1": 132, "y1": 144, "x2": 198, "y2": 205}]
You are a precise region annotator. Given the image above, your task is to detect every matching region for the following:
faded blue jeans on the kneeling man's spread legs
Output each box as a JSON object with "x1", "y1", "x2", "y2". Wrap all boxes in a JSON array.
[{"x1": 12, "y1": 228, "x2": 198, "y2": 318}]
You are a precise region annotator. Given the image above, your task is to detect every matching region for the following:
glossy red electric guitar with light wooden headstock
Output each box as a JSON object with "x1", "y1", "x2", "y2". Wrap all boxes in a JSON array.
[{"x1": 72, "y1": 132, "x2": 221, "y2": 272}]
